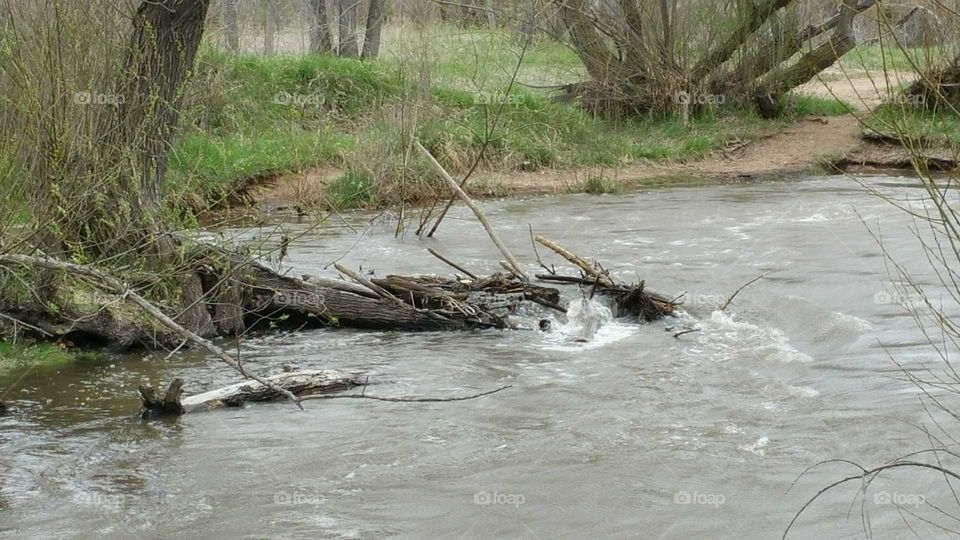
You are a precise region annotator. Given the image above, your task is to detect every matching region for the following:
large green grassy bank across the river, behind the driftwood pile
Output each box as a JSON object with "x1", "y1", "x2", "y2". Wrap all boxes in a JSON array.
[{"x1": 170, "y1": 29, "x2": 846, "y2": 209}]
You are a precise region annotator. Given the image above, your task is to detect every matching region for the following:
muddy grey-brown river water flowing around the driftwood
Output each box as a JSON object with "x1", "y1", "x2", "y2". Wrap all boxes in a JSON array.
[{"x1": 0, "y1": 177, "x2": 956, "y2": 539}]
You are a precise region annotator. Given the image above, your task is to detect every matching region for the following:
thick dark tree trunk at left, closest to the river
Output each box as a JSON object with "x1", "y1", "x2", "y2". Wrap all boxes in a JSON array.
[{"x1": 95, "y1": 0, "x2": 212, "y2": 333}]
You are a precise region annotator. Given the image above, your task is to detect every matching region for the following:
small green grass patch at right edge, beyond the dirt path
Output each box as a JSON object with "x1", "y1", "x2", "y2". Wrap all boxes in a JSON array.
[{"x1": 864, "y1": 105, "x2": 960, "y2": 148}]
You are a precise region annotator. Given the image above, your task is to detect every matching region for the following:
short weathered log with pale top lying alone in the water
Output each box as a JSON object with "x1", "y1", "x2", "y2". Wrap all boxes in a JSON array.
[{"x1": 139, "y1": 370, "x2": 363, "y2": 415}]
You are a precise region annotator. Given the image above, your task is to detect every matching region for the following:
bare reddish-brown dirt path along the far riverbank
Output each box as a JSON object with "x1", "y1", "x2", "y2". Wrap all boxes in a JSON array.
[{"x1": 254, "y1": 68, "x2": 916, "y2": 207}]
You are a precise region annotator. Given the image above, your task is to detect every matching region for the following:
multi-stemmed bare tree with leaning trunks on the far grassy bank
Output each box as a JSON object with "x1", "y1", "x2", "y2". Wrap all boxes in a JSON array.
[{"x1": 553, "y1": 0, "x2": 876, "y2": 116}]
